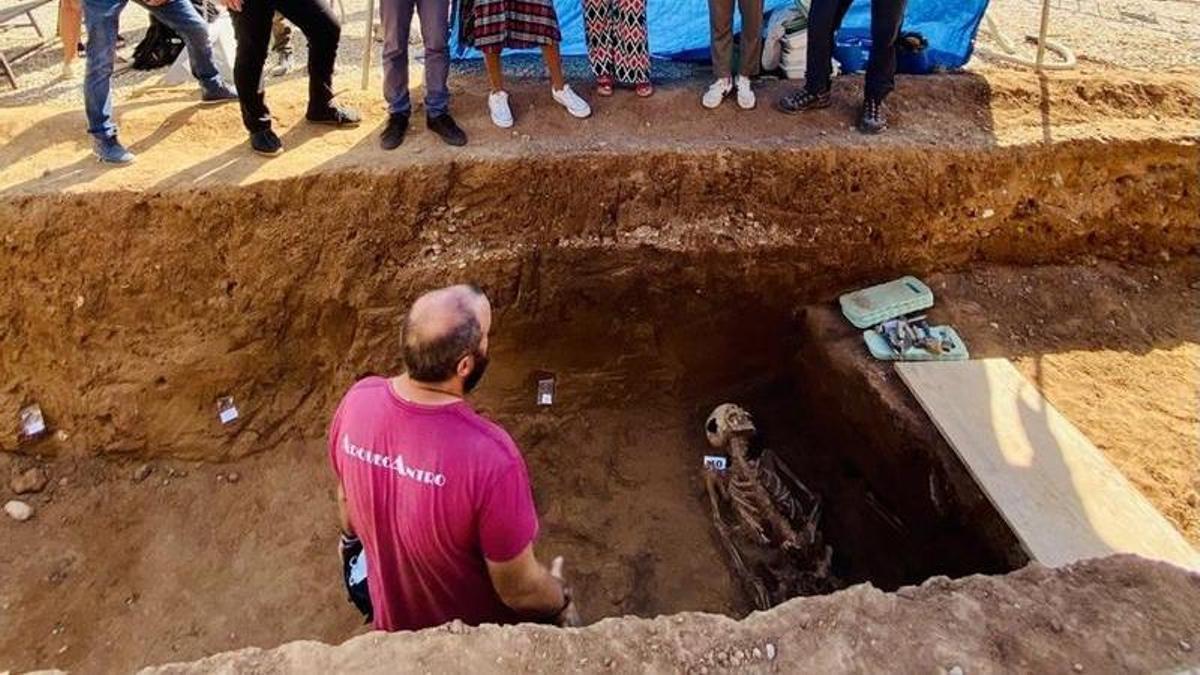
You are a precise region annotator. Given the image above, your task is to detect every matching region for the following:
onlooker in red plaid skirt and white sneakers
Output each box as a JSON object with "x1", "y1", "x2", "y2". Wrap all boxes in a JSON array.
[{"x1": 462, "y1": 0, "x2": 592, "y2": 129}]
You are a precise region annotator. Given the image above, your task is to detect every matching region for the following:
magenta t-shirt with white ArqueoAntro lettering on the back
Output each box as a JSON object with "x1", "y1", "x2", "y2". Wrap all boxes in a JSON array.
[{"x1": 329, "y1": 377, "x2": 538, "y2": 631}]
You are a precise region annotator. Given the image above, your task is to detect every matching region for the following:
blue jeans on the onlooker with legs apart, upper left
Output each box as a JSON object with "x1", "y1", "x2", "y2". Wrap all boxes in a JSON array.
[{"x1": 83, "y1": 0, "x2": 222, "y2": 138}]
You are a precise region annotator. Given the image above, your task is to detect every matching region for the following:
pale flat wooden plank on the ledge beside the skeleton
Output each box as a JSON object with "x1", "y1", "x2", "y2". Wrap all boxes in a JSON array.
[{"x1": 896, "y1": 359, "x2": 1200, "y2": 571}]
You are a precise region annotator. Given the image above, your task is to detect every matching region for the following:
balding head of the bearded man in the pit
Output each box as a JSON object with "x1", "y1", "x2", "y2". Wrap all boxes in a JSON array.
[{"x1": 400, "y1": 286, "x2": 492, "y2": 382}]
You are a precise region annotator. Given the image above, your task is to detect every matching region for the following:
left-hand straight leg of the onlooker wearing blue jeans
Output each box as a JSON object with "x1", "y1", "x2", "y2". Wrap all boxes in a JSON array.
[{"x1": 83, "y1": 0, "x2": 125, "y2": 139}]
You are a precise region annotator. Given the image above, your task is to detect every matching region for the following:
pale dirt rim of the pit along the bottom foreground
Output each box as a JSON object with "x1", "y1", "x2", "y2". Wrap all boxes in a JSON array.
[{"x1": 144, "y1": 556, "x2": 1200, "y2": 675}]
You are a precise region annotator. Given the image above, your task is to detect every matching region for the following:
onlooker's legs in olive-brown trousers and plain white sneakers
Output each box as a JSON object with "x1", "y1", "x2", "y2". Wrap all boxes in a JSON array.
[{"x1": 701, "y1": 0, "x2": 762, "y2": 110}]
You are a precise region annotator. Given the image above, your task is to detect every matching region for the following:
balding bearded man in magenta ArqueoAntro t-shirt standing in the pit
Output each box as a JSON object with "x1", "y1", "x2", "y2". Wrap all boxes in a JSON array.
[{"x1": 329, "y1": 286, "x2": 577, "y2": 631}]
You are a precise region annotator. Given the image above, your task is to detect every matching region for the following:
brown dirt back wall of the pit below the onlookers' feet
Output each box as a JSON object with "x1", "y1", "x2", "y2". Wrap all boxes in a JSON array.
[{"x1": 0, "y1": 142, "x2": 1200, "y2": 459}]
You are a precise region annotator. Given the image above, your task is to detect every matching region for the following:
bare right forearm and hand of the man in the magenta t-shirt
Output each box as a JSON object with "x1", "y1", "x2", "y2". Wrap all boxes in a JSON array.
[{"x1": 487, "y1": 544, "x2": 580, "y2": 626}]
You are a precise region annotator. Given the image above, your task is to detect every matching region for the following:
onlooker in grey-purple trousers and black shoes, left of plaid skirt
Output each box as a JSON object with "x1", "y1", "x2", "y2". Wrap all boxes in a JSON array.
[{"x1": 379, "y1": 0, "x2": 467, "y2": 150}]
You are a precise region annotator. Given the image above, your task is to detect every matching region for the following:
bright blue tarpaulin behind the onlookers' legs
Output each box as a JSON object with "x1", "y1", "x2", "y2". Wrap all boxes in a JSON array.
[{"x1": 451, "y1": 0, "x2": 988, "y2": 68}]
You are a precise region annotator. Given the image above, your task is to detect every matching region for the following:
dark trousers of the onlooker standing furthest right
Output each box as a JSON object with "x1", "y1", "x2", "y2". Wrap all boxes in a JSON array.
[{"x1": 806, "y1": 0, "x2": 907, "y2": 101}]
